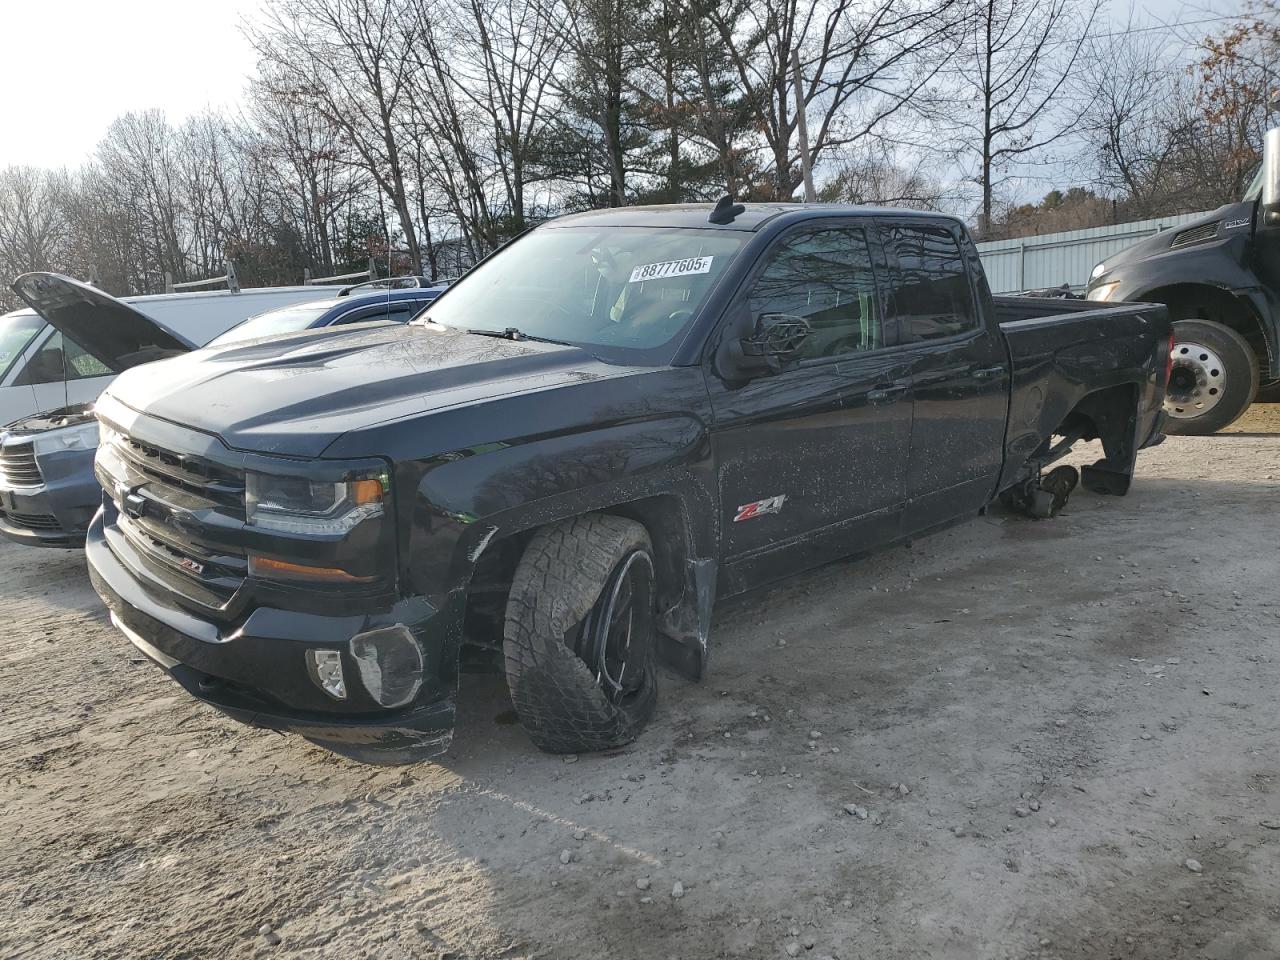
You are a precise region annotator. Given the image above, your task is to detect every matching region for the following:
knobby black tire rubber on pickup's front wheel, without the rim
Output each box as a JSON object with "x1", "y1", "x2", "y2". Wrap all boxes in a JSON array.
[{"x1": 503, "y1": 513, "x2": 658, "y2": 754}]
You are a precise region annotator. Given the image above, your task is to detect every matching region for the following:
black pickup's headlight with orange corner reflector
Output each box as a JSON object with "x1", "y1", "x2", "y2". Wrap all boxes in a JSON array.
[{"x1": 244, "y1": 471, "x2": 390, "y2": 535}]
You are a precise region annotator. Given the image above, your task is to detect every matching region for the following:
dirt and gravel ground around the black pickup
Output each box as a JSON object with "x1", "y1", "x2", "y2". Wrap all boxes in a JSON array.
[{"x1": 0, "y1": 406, "x2": 1280, "y2": 960}]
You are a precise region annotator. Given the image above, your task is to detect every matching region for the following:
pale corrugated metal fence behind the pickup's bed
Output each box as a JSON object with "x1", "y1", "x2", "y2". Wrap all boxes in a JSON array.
[{"x1": 978, "y1": 214, "x2": 1204, "y2": 293}]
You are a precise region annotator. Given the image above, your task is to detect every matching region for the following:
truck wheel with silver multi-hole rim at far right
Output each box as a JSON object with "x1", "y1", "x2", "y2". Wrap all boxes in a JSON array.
[{"x1": 1165, "y1": 320, "x2": 1258, "y2": 436}]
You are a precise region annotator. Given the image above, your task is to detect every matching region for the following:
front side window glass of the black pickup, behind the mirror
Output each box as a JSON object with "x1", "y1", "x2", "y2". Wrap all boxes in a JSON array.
[{"x1": 749, "y1": 228, "x2": 884, "y2": 358}]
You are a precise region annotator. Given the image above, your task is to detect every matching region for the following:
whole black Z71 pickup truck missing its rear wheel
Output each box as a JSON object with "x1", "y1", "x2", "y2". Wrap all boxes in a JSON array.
[{"x1": 70, "y1": 201, "x2": 1170, "y2": 763}]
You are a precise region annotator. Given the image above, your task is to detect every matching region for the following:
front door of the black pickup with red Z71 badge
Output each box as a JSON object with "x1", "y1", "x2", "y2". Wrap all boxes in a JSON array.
[{"x1": 708, "y1": 219, "x2": 911, "y2": 590}]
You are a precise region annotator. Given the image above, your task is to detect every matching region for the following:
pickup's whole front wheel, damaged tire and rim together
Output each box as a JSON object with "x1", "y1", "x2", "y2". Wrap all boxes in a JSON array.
[{"x1": 503, "y1": 513, "x2": 658, "y2": 753}]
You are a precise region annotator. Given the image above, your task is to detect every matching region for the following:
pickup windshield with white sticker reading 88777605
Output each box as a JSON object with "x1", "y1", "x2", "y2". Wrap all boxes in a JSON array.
[{"x1": 425, "y1": 227, "x2": 748, "y2": 362}]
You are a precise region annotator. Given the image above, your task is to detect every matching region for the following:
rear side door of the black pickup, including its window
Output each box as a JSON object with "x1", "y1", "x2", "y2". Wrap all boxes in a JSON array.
[{"x1": 881, "y1": 218, "x2": 1009, "y2": 532}]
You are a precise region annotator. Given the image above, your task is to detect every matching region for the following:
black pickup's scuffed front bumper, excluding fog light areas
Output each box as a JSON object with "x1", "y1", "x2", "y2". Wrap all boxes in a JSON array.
[{"x1": 86, "y1": 513, "x2": 460, "y2": 763}]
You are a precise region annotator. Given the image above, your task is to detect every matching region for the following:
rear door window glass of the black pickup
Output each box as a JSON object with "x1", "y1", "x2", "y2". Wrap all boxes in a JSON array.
[{"x1": 884, "y1": 224, "x2": 978, "y2": 343}]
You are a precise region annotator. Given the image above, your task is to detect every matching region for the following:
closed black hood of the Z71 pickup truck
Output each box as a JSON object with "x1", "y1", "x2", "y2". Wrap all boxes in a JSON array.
[{"x1": 99, "y1": 324, "x2": 630, "y2": 457}]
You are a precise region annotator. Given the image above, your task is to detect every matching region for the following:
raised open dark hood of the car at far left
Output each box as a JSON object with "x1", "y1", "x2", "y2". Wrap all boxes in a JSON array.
[{"x1": 13, "y1": 273, "x2": 196, "y2": 372}]
